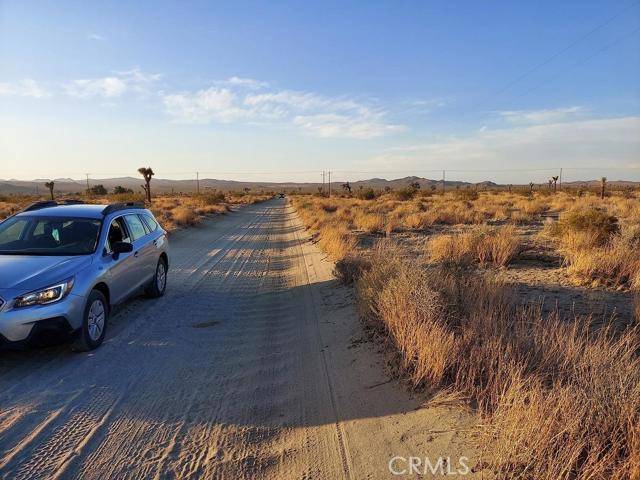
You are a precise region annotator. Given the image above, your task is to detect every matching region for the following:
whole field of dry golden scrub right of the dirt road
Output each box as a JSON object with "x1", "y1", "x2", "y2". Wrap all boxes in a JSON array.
[{"x1": 293, "y1": 188, "x2": 640, "y2": 480}]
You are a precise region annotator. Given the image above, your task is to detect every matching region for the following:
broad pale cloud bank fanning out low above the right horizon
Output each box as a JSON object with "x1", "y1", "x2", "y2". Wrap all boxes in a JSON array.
[{"x1": 368, "y1": 116, "x2": 640, "y2": 170}]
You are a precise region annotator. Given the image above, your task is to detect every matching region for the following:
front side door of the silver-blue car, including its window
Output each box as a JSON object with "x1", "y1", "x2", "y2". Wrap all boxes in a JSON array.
[{"x1": 103, "y1": 216, "x2": 140, "y2": 304}]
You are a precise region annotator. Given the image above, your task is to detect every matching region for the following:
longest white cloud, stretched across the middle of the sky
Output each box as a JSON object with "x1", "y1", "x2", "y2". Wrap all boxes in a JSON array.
[{"x1": 163, "y1": 82, "x2": 402, "y2": 139}]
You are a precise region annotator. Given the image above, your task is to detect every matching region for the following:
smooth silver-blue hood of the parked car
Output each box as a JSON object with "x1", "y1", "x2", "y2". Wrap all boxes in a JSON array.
[{"x1": 0, "y1": 255, "x2": 92, "y2": 291}]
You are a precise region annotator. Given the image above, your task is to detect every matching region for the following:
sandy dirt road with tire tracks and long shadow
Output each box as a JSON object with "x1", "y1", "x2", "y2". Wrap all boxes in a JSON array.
[{"x1": 0, "y1": 200, "x2": 482, "y2": 479}]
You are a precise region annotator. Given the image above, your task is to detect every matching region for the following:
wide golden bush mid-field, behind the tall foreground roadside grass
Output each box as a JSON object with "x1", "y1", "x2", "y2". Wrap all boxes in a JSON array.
[{"x1": 427, "y1": 225, "x2": 522, "y2": 267}]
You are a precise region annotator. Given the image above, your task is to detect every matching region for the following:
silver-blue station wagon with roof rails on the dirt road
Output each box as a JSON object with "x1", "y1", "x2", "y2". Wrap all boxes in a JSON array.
[{"x1": 0, "y1": 202, "x2": 169, "y2": 351}]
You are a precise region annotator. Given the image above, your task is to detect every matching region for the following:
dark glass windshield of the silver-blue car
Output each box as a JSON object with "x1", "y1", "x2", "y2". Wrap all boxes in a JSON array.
[{"x1": 0, "y1": 216, "x2": 102, "y2": 255}]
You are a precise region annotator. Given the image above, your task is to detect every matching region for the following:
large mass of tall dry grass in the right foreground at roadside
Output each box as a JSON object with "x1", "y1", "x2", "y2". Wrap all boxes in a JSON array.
[{"x1": 357, "y1": 246, "x2": 640, "y2": 480}]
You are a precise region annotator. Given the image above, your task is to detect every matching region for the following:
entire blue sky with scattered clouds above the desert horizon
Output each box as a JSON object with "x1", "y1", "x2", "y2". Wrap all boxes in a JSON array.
[{"x1": 0, "y1": 0, "x2": 640, "y2": 182}]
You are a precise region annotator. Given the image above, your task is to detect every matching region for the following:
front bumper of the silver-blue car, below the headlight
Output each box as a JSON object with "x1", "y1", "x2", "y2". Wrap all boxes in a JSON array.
[{"x1": 0, "y1": 290, "x2": 85, "y2": 344}]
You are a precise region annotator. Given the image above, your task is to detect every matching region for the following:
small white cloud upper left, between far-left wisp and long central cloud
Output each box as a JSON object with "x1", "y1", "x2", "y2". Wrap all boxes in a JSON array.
[{"x1": 64, "y1": 68, "x2": 162, "y2": 99}]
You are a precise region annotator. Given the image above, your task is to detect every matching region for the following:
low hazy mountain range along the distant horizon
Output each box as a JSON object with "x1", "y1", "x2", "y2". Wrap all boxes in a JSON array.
[{"x1": 0, "y1": 177, "x2": 640, "y2": 195}]
